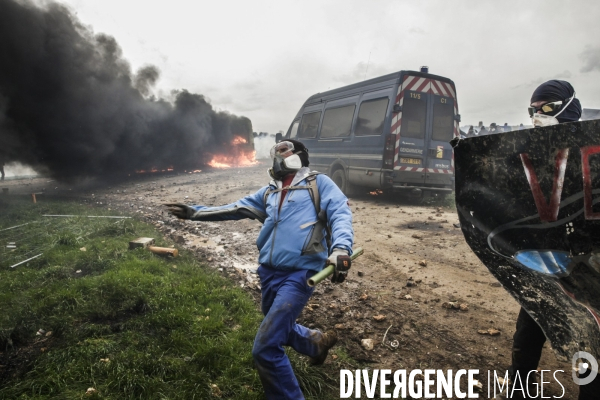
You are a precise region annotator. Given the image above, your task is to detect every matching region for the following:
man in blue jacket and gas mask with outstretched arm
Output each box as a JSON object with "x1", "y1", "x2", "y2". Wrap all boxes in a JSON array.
[{"x1": 167, "y1": 140, "x2": 354, "y2": 399}]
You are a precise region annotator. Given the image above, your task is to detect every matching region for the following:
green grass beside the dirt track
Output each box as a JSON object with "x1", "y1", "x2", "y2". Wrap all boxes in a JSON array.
[{"x1": 0, "y1": 199, "x2": 339, "y2": 399}]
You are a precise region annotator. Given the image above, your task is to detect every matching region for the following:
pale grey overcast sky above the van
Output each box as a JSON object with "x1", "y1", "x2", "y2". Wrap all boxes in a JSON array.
[{"x1": 61, "y1": 0, "x2": 600, "y2": 133}]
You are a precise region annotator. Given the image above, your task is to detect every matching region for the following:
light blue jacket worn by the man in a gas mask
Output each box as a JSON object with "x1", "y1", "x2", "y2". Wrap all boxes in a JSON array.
[{"x1": 192, "y1": 167, "x2": 354, "y2": 271}]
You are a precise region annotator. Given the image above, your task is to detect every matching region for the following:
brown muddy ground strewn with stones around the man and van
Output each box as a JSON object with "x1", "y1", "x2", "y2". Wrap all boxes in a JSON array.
[{"x1": 0, "y1": 163, "x2": 577, "y2": 399}]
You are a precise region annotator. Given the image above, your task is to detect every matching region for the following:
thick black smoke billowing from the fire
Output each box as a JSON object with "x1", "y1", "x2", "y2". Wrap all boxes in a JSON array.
[{"x1": 0, "y1": 0, "x2": 252, "y2": 180}]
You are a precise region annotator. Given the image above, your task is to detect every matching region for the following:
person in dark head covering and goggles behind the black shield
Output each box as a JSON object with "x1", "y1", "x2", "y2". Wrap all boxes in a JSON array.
[{"x1": 509, "y1": 80, "x2": 600, "y2": 400}]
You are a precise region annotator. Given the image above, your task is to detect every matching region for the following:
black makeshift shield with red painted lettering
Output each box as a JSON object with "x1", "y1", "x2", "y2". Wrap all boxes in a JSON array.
[{"x1": 453, "y1": 121, "x2": 600, "y2": 360}]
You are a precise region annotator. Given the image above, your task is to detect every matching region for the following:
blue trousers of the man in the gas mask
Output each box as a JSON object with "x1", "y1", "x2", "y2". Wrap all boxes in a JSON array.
[{"x1": 252, "y1": 265, "x2": 323, "y2": 400}]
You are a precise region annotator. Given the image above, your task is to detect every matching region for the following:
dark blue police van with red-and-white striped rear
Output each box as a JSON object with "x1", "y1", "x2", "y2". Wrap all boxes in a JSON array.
[{"x1": 277, "y1": 67, "x2": 460, "y2": 198}]
